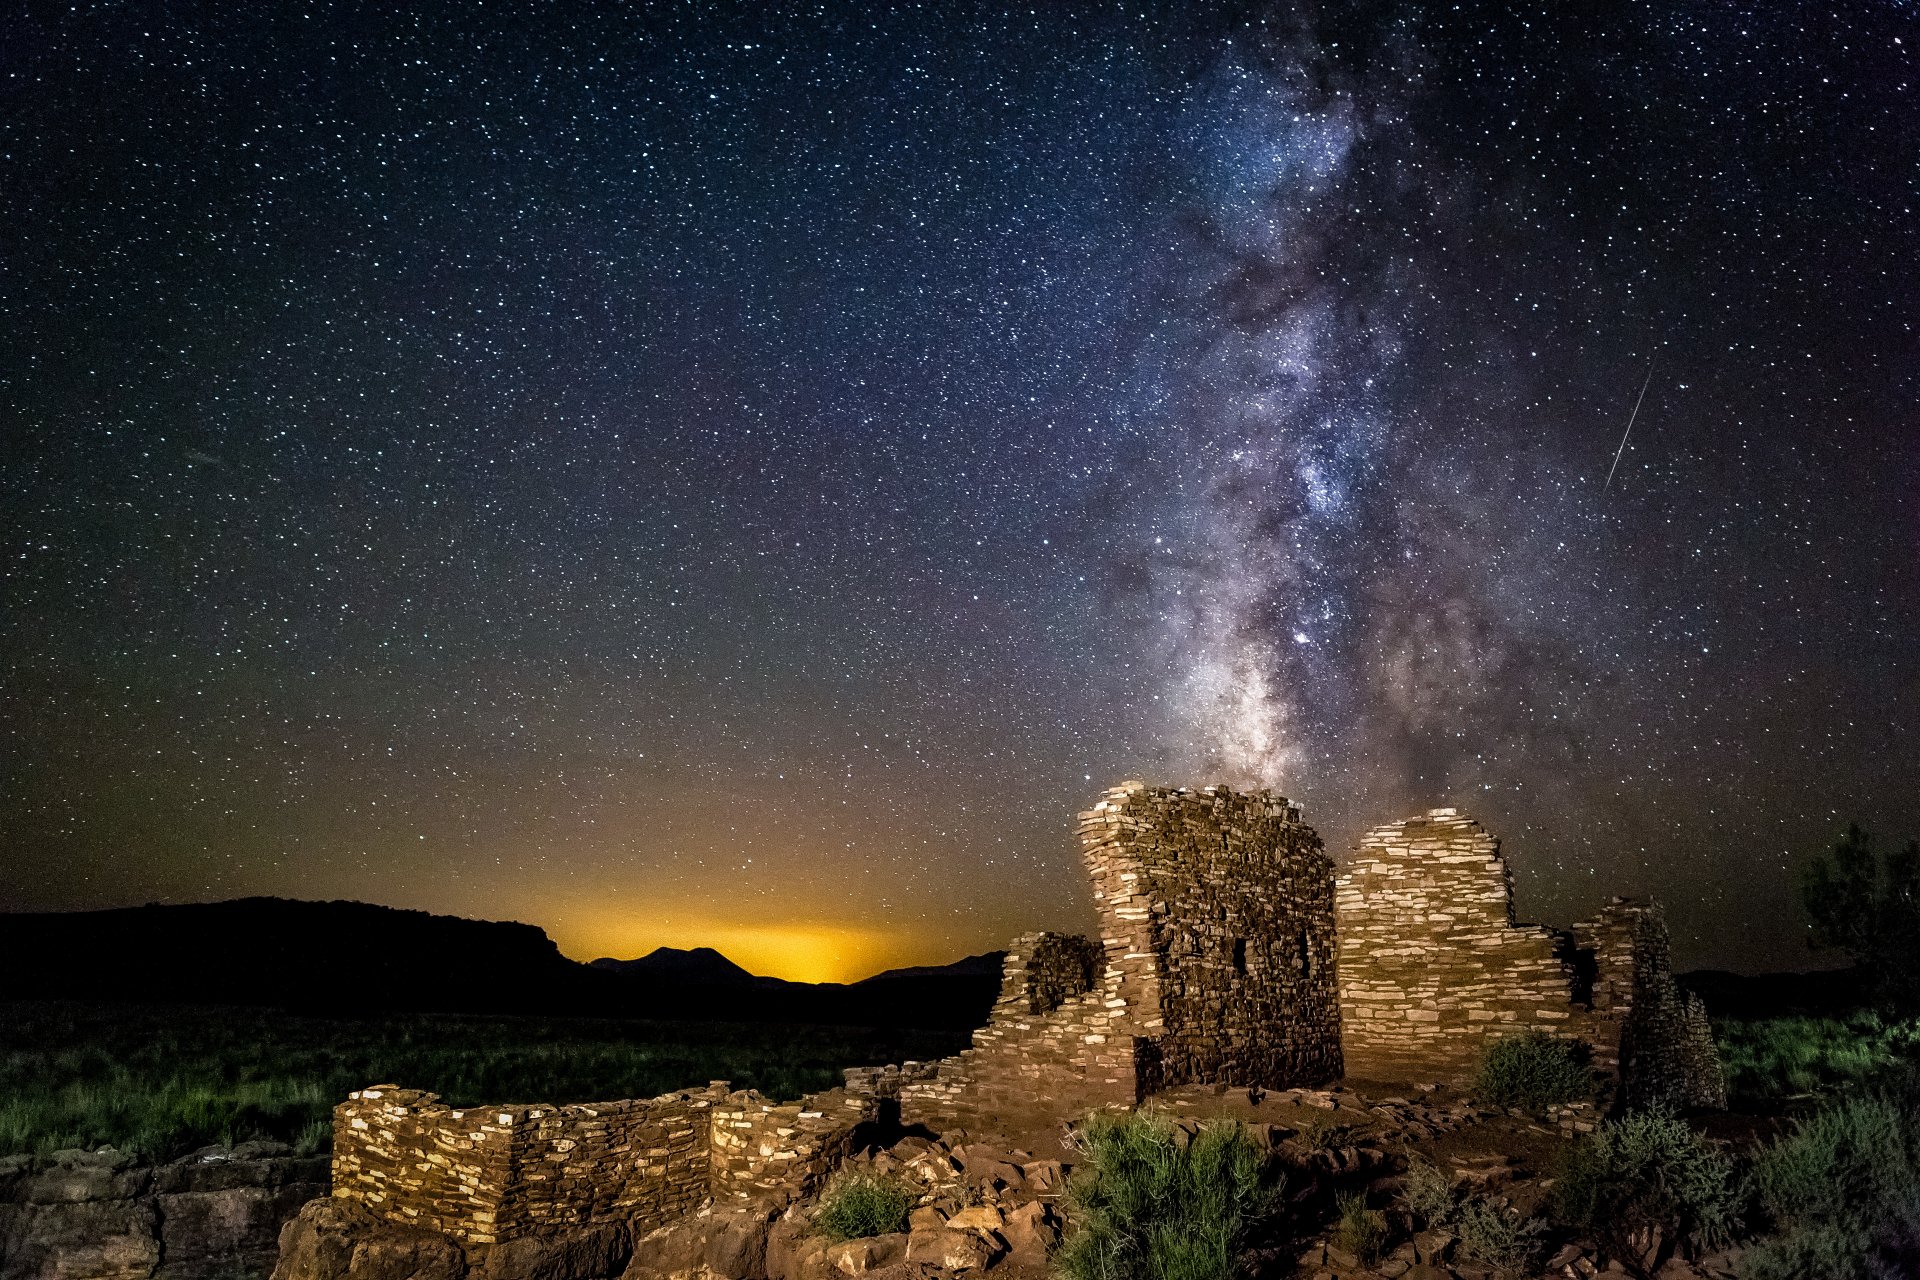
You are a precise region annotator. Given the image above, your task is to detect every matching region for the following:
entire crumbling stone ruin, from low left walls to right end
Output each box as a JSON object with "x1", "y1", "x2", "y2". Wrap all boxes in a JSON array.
[{"x1": 314, "y1": 783, "x2": 1726, "y2": 1274}]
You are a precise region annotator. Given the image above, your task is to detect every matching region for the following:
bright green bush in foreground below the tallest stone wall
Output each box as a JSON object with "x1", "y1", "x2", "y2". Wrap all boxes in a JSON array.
[{"x1": 1054, "y1": 1111, "x2": 1279, "y2": 1280}]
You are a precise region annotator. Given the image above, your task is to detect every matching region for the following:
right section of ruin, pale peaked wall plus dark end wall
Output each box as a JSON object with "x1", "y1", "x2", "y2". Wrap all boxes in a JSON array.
[{"x1": 1334, "y1": 808, "x2": 1726, "y2": 1107}]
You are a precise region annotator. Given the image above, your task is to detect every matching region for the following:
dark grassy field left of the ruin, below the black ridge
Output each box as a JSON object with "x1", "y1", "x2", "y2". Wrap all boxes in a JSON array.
[{"x1": 0, "y1": 1004, "x2": 966, "y2": 1159}]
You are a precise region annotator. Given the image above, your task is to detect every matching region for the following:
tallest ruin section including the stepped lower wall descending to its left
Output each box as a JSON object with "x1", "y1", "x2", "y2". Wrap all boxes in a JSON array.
[{"x1": 899, "y1": 783, "x2": 1340, "y2": 1130}]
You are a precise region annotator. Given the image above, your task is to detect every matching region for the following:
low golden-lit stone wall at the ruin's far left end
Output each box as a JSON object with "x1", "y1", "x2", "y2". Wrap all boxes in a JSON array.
[{"x1": 332, "y1": 1080, "x2": 879, "y2": 1245}]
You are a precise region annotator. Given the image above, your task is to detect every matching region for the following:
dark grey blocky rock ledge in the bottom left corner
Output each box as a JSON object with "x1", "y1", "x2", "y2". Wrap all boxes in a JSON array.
[{"x1": 0, "y1": 1142, "x2": 326, "y2": 1280}]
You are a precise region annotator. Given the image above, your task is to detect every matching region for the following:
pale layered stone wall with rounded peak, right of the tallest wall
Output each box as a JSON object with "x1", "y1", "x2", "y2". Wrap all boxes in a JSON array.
[{"x1": 1334, "y1": 808, "x2": 1574, "y2": 1080}]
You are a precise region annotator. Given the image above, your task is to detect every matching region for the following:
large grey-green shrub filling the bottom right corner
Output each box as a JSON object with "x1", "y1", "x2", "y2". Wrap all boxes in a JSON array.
[{"x1": 1743, "y1": 1086, "x2": 1920, "y2": 1280}]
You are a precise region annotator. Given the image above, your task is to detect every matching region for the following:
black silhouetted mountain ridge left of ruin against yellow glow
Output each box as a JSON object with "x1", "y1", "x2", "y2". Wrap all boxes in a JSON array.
[{"x1": 0, "y1": 898, "x2": 998, "y2": 1027}]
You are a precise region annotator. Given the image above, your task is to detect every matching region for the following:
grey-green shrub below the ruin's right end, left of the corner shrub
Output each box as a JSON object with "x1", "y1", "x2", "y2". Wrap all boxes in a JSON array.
[{"x1": 1553, "y1": 1111, "x2": 1741, "y2": 1267}]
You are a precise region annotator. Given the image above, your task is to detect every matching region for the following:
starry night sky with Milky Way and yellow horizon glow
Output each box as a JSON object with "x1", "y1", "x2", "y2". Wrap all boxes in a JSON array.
[{"x1": 0, "y1": 0, "x2": 1920, "y2": 977}]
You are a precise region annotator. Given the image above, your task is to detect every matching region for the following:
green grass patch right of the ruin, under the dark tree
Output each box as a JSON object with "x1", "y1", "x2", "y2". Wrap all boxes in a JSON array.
[{"x1": 1715, "y1": 1009, "x2": 1920, "y2": 1107}]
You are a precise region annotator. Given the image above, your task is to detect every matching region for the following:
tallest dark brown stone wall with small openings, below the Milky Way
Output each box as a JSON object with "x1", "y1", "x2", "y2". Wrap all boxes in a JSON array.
[{"x1": 1079, "y1": 783, "x2": 1340, "y2": 1088}]
